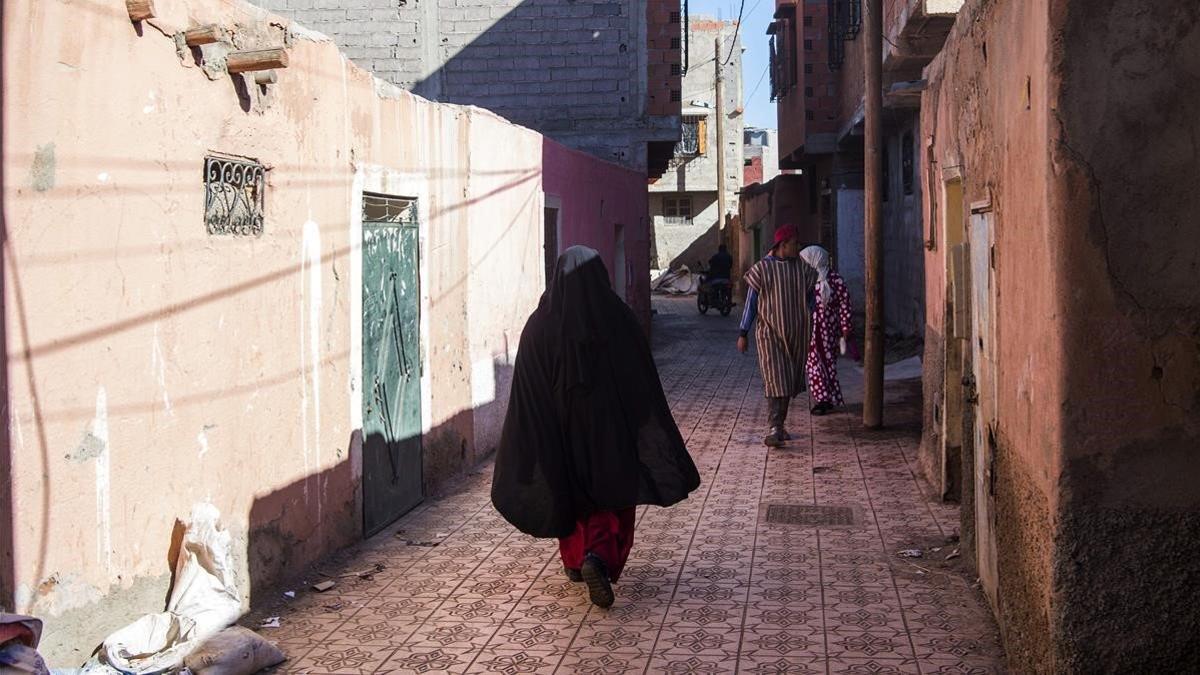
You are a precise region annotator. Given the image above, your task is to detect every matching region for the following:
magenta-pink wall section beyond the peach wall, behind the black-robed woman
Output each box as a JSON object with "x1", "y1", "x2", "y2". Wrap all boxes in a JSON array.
[{"x1": 542, "y1": 139, "x2": 650, "y2": 329}]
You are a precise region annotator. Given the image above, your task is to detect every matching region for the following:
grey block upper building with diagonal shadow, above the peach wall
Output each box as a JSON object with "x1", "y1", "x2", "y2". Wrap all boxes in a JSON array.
[{"x1": 256, "y1": 0, "x2": 684, "y2": 175}]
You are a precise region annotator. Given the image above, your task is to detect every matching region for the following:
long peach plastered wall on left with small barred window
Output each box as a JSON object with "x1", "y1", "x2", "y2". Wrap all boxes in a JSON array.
[{"x1": 0, "y1": 0, "x2": 646, "y2": 664}]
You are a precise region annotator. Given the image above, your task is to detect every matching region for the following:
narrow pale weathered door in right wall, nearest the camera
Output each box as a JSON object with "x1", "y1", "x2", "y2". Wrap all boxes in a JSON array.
[{"x1": 967, "y1": 211, "x2": 998, "y2": 602}]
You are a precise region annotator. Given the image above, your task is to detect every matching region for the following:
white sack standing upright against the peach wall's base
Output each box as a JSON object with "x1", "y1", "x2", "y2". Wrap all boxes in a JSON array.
[{"x1": 167, "y1": 503, "x2": 241, "y2": 640}]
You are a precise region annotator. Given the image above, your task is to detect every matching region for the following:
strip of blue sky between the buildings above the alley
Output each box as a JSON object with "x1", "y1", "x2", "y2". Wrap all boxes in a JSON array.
[{"x1": 688, "y1": 0, "x2": 775, "y2": 129}]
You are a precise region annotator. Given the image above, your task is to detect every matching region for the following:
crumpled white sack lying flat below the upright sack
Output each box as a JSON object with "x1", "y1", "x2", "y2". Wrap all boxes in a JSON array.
[{"x1": 103, "y1": 611, "x2": 198, "y2": 675}]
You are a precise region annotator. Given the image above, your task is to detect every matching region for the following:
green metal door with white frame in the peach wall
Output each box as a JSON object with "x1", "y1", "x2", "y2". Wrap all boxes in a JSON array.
[{"x1": 362, "y1": 195, "x2": 424, "y2": 536}]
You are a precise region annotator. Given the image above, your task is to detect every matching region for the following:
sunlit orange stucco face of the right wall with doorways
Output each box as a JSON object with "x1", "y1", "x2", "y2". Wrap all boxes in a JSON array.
[{"x1": 920, "y1": 1, "x2": 1067, "y2": 671}]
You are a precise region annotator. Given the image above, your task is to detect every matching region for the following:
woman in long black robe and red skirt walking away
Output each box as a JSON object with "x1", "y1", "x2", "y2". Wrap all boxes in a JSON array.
[{"x1": 492, "y1": 246, "x2": 700, "y2": 608}]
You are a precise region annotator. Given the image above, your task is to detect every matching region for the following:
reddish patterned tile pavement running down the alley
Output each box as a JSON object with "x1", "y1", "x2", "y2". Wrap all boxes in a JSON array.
[{"x1": 253, "y1": 299, "x2": 1002, "y2": 674}]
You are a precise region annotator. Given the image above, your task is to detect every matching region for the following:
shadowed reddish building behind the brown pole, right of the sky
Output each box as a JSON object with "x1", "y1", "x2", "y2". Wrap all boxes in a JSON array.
[{"x1": 770, "y1": 0, "x2": 962, "y2": 336}]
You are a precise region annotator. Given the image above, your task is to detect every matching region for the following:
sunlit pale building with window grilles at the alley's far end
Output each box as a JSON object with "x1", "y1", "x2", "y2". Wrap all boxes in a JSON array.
[{"x1": 649, "y1": 17, "x2": 745, "y2": 269}]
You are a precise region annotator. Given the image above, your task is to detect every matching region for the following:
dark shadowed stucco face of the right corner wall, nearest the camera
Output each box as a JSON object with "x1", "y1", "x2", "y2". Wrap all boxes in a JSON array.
[{"x1": 1050, "y1": 0, "x2": 1200, "y2": 673}]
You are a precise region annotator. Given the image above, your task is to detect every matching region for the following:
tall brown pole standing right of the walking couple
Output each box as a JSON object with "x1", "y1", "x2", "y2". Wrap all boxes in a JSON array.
[{"x1": 863, "y1": 0, "x2": 883, "y2": 429}]
